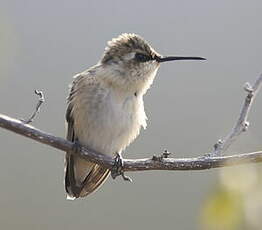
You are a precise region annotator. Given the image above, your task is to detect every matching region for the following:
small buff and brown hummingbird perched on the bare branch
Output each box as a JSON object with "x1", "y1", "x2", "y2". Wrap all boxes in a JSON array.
[{"x1": 65, "y1": 33, "x2": 205, "y2": 199}]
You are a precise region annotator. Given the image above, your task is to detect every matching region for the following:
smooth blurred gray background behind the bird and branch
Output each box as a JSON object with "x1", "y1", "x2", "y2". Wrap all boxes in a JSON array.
[{"x1": 0, "y1": 0, "x2": 262, "y2": 230}]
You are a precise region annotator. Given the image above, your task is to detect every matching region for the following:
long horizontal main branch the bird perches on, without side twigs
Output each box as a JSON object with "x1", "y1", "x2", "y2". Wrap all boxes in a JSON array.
[{"x1": 0, "y1": 114, "x2": 262, "y2": 171}]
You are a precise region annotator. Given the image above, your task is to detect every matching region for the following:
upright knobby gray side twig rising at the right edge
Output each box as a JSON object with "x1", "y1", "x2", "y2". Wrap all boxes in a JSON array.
[{"x1": 209, "y1": 74, "x2": 262, "y2": 156}]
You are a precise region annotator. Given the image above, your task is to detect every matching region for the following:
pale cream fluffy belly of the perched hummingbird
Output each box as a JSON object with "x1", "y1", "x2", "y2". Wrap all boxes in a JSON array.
[{"x1": 74, "y1": 94, "x2": 146, "y2": 155}]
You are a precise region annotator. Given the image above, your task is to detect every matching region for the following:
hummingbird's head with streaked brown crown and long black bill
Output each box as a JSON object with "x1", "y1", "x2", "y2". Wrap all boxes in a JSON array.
[{"x1": 101, "y1": 33, "x2": 205, "y2": 92}]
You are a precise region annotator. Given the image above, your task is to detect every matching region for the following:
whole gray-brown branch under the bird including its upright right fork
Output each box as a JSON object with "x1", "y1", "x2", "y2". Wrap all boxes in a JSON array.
[{"x1": 0, "y1": 75, "x2": 262, "y2": 171}]
